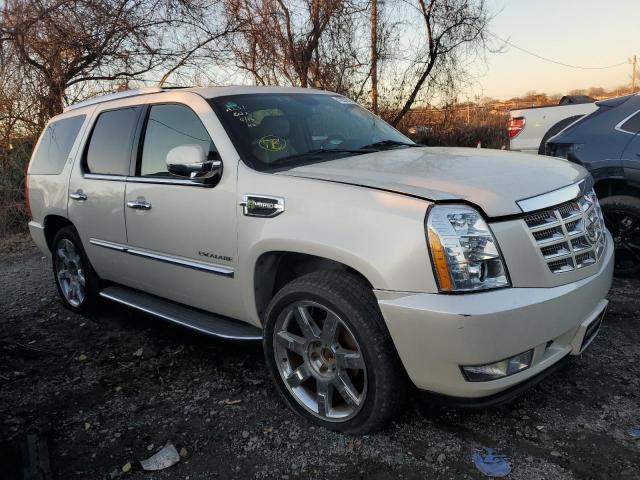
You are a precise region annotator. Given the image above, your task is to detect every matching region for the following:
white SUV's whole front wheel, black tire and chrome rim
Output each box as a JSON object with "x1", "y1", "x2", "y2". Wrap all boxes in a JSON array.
[{"x1": 263, "y1": 271, "x2": 407, "y2": 434}]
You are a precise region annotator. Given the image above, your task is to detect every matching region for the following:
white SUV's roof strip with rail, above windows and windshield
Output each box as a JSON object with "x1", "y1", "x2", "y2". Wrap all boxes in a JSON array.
[{"x1": 64, "y1": 85, "x2": 332, "y2": 112}]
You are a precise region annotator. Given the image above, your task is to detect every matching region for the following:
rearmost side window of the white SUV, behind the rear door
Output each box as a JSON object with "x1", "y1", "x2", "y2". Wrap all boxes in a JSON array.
[{"x1": 30, "y1": 115, "x2": 85, "y2": 175}]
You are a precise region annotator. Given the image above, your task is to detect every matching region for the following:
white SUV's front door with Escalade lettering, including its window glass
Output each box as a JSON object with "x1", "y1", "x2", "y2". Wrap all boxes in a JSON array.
[{"x1": 125, "y1": 103, "x2": 239, "y2": 317}]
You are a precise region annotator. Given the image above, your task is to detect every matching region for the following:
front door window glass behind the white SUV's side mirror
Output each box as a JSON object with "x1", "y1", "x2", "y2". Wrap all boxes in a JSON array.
[{"x1": 139, "y1": 105, "x2": 215, "y2": 177}]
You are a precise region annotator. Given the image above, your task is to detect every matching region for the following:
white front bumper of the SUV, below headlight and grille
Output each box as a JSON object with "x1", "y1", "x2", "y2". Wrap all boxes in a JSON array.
[{"x1": 375, "y1": 233, "x2": 613, "y2": 399}]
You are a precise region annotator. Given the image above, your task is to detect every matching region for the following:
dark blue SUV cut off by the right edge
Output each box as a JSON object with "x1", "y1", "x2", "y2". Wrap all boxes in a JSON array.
[{"x1": 546, "y1": 94, "x2": 640, "y2": 276}]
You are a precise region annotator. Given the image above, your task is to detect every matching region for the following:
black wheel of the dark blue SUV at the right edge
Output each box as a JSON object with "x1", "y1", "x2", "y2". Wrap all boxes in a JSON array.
[{"x1": 600, "y1": 195, "x2": 640, "y2": 277}]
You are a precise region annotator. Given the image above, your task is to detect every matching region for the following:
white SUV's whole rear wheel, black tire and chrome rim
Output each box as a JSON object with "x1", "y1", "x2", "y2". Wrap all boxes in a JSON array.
[{"x1": 51, "y1": 227, "x2": 100, "y2": 313}]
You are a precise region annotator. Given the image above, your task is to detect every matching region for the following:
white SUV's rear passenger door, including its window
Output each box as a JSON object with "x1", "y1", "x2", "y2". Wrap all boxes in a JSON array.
[{"x1": 68, "y1": 106, "x2": 142, "y2": 281}]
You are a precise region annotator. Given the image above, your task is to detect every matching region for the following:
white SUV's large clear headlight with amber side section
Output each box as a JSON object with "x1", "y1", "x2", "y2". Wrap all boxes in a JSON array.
[{"x1": 425, "y1": 205, "x2": 510, "y2": 292}]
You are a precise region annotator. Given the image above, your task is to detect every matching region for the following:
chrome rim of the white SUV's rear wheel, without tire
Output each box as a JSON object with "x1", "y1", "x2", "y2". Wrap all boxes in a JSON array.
[{"x1": 55, "y1": 238, "x2": 87, "y2": 307}]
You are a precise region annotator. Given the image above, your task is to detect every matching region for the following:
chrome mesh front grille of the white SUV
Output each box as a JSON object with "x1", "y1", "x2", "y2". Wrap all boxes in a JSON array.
[{"x1": 524, "y1": 190, "x2": 606, "y2": 273}]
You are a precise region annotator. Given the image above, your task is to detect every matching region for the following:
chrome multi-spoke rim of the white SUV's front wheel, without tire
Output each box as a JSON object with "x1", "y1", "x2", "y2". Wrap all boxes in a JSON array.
[{"x1": 273, "y1": 301, "x2": 367, "y2": 422}]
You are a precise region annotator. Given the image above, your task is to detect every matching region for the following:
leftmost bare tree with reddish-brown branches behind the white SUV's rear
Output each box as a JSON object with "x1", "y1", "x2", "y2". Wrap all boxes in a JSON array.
[{"x1": 0, "y1": 0, "x2": 234, "y2": 124}]
